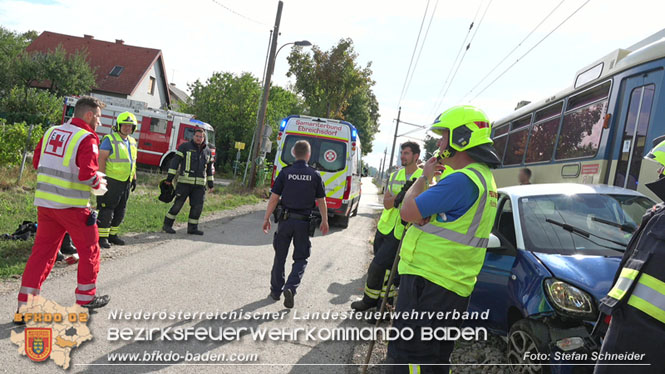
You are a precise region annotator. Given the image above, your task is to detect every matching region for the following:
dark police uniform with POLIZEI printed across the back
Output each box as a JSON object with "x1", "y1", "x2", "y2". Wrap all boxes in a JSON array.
[{"x1": 270, "y1": 160, "x2": 326, "y2": 297}]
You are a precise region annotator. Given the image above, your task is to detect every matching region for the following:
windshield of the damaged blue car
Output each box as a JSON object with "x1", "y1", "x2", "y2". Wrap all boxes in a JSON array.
[{"x1": 519, "y1": 194, "x2": 653, "y2": 256}]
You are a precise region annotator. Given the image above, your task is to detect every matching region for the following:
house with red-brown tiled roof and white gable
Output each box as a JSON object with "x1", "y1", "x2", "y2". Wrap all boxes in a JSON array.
[{"x1": 26, "y1": 31, "x2": 171, "y2": 109}]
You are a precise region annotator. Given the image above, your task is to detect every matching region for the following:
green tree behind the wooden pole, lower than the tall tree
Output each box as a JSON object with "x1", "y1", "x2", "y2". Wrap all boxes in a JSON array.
[{"x1": 182, "y1": 72, "x2": 303, "y2": 165}]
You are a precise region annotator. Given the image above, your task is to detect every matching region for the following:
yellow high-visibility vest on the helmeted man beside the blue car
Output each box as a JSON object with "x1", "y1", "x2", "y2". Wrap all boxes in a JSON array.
[{"x1": 399, "y1": 163, "x2": 498, "y2": 297}]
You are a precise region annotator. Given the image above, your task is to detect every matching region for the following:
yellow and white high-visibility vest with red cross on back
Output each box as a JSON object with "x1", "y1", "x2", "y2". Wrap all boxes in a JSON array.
[{"x1": 35, "y1": 123, "x2": 96, "y2": 209}]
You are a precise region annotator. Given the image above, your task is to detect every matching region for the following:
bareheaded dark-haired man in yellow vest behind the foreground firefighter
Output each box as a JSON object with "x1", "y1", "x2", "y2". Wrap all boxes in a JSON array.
[{"x1": 351, "y1": 142, "x2": 423, "y2": 311}]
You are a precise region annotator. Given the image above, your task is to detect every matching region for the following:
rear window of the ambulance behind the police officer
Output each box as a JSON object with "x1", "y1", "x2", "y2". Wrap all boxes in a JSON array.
[{"x1": 282, "y1": 135, "x2": 346, "y2": 172}]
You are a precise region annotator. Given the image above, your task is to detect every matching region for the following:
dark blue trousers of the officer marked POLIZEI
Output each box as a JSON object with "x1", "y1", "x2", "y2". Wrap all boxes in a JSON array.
[{"x1": 270, "y1": 218, "x2": 312, "y2": 296}]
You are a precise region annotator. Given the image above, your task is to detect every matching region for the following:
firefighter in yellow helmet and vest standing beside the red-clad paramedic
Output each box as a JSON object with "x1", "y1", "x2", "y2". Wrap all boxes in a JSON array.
[{"x1": 97, "y1": 112, "x2": 138, "y2": 248}]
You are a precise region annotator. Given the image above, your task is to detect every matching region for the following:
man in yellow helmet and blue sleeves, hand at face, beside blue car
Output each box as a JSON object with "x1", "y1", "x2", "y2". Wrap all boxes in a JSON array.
[{"x1": 388, "y1": 105, "x2": 500, "y2": 373}]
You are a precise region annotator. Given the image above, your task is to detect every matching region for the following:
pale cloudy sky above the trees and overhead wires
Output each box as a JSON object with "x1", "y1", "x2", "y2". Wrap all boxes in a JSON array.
[{"x1": 0, "y1": 0, "x2": 665, "y2": 166}]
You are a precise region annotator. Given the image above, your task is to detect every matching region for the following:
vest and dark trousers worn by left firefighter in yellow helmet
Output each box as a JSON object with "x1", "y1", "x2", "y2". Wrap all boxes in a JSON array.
[{"x1": 97, "y1": 131, "x2": 138, "y2": 247}]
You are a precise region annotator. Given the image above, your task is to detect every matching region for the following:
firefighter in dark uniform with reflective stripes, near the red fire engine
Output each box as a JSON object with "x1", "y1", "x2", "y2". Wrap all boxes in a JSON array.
[{"x1": 162, "y1": 128, "x2": 214, "y2": 235}]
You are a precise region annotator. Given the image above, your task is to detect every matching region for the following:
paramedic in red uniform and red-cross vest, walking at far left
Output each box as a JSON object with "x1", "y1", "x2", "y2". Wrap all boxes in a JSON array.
[{"x1": 14, "y1": 96, "x2": 110, "y2": 324}]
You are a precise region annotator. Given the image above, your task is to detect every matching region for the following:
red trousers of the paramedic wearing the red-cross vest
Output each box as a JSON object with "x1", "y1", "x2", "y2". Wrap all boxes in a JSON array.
[{"x1": 18, "y1": 207, "x2": 100, "y2": 307}]
